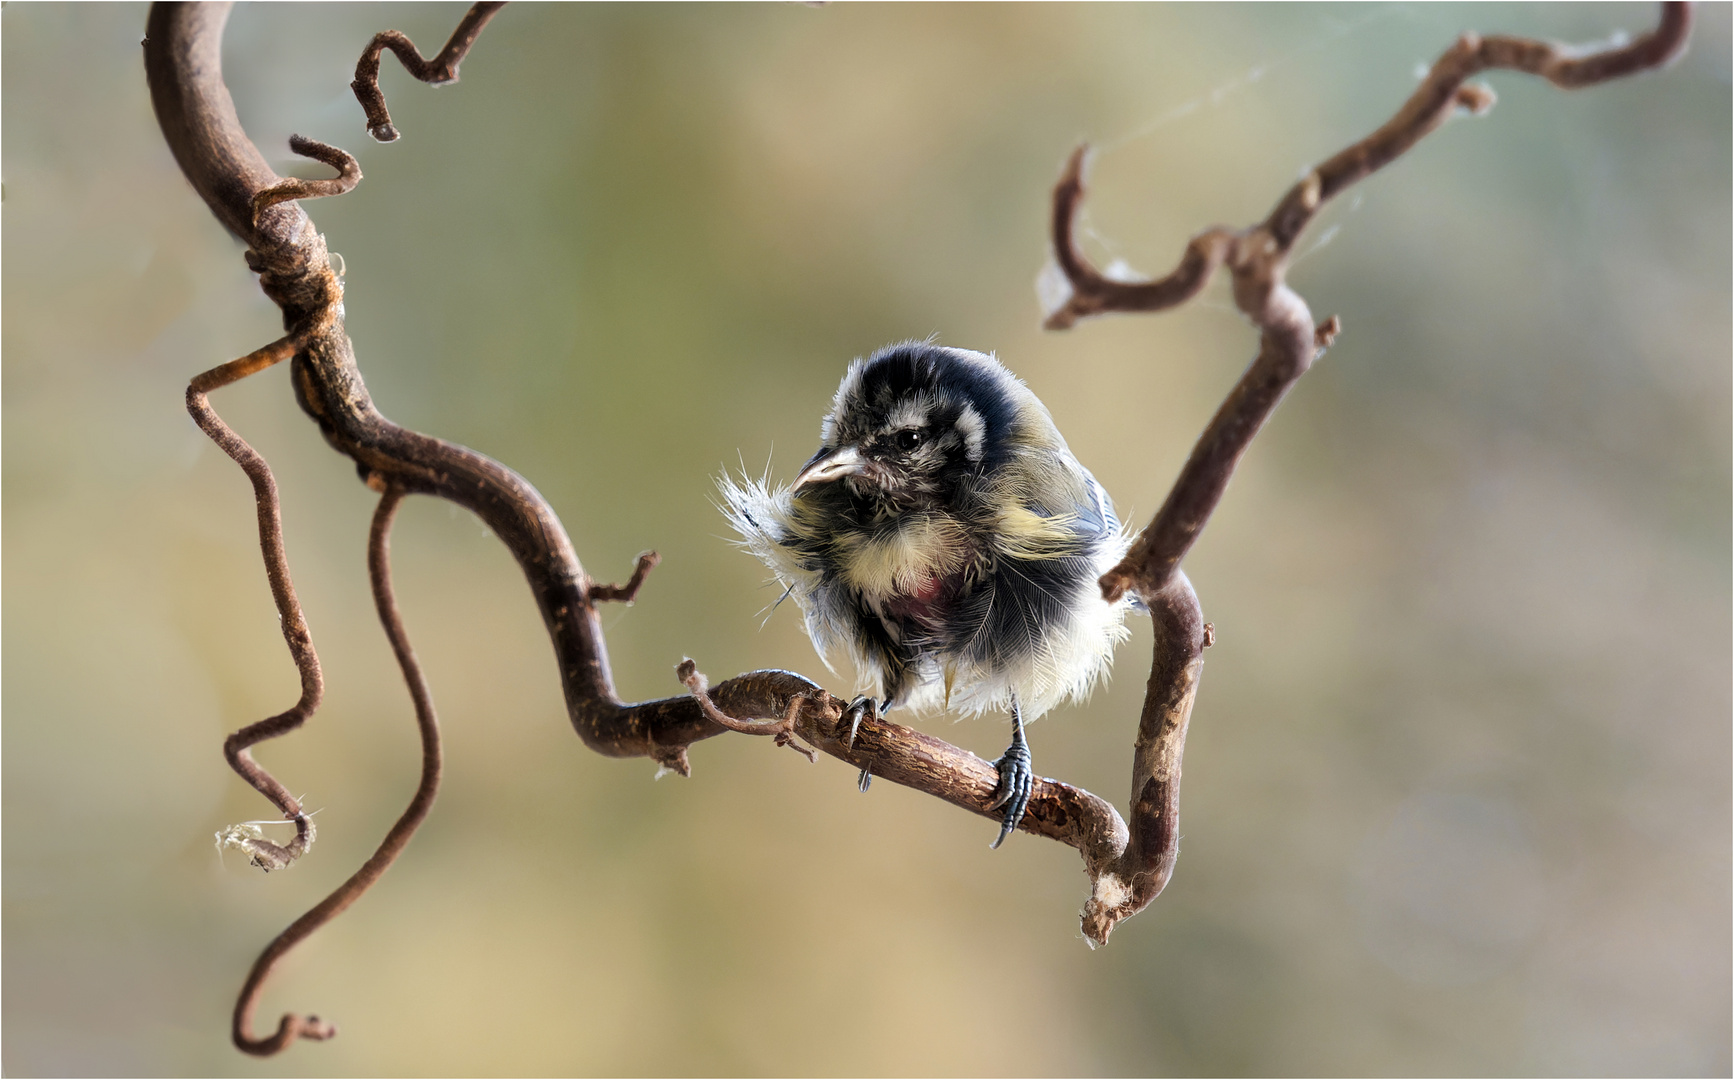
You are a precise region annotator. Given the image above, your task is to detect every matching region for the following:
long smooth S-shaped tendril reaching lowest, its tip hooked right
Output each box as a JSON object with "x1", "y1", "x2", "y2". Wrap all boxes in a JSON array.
[{"x1": 232, "y1": 487, "x2": 442, "y2": 1057}]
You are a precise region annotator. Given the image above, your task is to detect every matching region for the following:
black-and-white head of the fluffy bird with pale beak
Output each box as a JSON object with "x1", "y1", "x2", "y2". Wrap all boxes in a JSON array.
[{"x1": 792, "y1": 342, "x2": 1065, "y2": 511}]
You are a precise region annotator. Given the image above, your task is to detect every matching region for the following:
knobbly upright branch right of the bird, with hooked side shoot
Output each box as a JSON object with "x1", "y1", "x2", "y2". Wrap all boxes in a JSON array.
[{"x1": 1046, "y1": 3, "x2": 1691, "y2": 943}]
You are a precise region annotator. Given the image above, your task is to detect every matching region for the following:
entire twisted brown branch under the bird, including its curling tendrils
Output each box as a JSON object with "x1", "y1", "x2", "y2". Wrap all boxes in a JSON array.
[{"x1": 144, "y1": 3, "x2": 1687, "y2": 1054}]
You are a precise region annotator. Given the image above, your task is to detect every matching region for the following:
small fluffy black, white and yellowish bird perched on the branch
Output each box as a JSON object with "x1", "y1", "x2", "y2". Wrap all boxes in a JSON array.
[{"x1": 721, "y1": 342, "x2": 1131, "y2": 848}]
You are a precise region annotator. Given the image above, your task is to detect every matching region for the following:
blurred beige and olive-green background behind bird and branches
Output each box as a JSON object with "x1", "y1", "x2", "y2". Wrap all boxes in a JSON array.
[{"x1": 0, "y1": 3, "x2": 1731, "y2": 1075}]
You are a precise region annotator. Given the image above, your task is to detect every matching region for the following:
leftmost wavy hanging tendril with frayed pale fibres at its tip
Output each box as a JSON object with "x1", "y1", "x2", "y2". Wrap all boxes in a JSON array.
[{"x1": 187, "y1": 338, "x2": 324, "y2": 870}]
